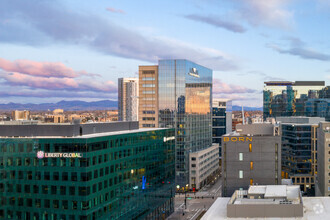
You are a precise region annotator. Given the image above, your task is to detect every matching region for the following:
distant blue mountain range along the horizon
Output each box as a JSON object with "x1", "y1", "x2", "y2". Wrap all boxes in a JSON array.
[{"x1": 0, "y1": 100, "x2": 262, "y2": 111}]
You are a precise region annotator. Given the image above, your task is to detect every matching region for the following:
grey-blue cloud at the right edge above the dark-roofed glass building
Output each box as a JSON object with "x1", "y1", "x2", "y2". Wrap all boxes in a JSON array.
[{"x1": 267, "y1": 38, "x2": 330, "y2": 61}]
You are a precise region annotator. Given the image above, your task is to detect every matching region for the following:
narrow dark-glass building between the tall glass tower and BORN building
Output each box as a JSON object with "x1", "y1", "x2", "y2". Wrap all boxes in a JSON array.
[{"x1": 212, "y1": 99, "x2": 232, "y2": 158}]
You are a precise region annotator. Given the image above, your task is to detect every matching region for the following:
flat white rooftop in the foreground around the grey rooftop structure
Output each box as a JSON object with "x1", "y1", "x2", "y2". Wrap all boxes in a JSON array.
[{"x1": 202, "y1": 197, "x2": 330, "y2": 220}]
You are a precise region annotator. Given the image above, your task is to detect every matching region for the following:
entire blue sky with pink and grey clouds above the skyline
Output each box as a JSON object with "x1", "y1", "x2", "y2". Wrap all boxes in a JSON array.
[{"x1": 0, "y1": 0, "x2": 330, "y2": 107}]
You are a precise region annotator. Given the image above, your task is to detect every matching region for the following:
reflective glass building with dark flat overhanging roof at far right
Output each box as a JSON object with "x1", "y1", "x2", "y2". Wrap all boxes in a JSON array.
[{"x1": 263, "y1": 81, "x2": 330, "y2": 120}]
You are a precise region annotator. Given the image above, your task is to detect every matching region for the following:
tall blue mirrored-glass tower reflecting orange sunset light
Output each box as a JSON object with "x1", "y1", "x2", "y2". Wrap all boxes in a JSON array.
[{"x1": 158, "y1": 60, "x2": 212, "y2": 188}]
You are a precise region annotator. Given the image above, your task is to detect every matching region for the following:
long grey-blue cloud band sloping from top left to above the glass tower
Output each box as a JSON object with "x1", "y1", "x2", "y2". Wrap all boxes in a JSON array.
[{"x1": 0, "y1": 0, "x2": 238, "y2": 70}]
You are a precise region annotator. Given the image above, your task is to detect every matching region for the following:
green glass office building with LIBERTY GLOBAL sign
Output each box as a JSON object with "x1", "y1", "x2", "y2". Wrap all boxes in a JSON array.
[{"x1": 0, "y1": 122, "x2": 175, "y2": 220}]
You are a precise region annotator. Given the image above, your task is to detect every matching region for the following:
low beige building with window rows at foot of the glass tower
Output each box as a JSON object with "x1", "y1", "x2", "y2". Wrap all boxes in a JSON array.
[{"x1": 189, "y1": 144, "x2": 220, "y2": 190}]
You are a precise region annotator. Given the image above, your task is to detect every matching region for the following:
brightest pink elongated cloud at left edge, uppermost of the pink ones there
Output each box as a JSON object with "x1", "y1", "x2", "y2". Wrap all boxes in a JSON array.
[{"x1": 0, "y1": 58, "x2": 90, "y2": 78}]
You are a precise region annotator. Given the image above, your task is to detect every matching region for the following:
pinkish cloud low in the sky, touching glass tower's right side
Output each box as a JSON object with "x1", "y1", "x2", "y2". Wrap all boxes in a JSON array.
[{"x1": 212, "y1": 79, "x2": 258, "y2": 94}]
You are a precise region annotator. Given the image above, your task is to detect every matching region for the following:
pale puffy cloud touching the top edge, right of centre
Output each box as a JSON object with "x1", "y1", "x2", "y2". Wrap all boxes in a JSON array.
[{"x1": 234, "y1": 0, "x2": 293, "y2": 28}]
